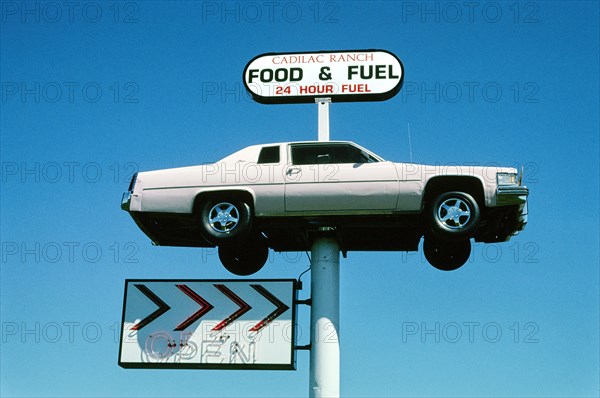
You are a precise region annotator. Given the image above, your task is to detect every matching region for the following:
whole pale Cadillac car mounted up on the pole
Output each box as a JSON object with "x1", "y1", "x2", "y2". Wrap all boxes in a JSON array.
[{"x1": 121, "y1": 141, "x2": 529, "y2": 275}]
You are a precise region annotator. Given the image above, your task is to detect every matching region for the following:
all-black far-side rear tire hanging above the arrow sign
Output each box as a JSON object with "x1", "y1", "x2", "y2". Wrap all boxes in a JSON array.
[{"x1": 219, "y1": 235, "x2": 269, "y2": 276}]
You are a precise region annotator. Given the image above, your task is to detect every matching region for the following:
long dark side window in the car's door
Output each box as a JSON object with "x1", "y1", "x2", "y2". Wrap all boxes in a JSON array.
[{"x1": 292, "y1": 144, "x2": 376, "y2": 165}]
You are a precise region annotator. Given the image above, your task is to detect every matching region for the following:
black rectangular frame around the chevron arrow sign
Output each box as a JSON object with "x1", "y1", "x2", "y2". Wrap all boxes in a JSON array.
[{"x1": 118, "y1": 279, "x2": 300, "y2": 370}]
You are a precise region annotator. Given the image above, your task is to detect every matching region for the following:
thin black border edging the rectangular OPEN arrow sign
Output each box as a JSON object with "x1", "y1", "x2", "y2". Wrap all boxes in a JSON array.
[{"x1": 118, "y1": 279, "x2": 298, "y2": 370}]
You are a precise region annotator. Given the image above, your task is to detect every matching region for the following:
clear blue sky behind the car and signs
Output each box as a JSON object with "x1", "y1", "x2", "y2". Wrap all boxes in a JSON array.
[{"x1": 0, "y1": 1, "x2": 600, "y2": 397}]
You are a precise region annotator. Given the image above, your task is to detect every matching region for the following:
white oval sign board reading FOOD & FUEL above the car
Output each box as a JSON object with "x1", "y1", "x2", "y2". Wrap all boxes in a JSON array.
[{"x1": 244, "y1": 50, "x2": 404, "y2": 104}]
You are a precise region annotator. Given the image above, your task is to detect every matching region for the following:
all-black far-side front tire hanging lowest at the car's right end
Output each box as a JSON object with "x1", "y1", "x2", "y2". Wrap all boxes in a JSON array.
[{"x1": 423, "y1": 237, "x2": 471, "y2": 271}]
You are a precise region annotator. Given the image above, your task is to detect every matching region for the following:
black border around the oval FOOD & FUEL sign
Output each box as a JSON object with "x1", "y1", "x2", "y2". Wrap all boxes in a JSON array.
[{"x1": 242, "y1": 49, "x2": 404, "y2": 105}]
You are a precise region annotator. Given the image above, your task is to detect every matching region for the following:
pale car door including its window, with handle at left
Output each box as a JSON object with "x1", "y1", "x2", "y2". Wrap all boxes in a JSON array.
[{"x1": 285, "y1": 143, "x2": 399, "y2": 214}]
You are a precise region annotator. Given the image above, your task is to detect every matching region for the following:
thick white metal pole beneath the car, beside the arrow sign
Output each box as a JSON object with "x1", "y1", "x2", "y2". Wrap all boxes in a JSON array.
[{"x1": 309, "y1": 232, "x2": 340, "y2": 398}]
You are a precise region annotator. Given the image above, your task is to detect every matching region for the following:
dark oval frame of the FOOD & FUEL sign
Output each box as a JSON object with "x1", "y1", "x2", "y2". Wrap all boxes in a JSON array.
[{"x1": 242, "y1": 49, "x2": 404, "y2": 104}]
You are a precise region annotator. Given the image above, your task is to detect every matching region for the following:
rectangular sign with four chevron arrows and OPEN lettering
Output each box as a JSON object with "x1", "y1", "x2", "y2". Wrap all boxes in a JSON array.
[{"x1": 119, "y1": 279, "x2": 297, "y2": 370}]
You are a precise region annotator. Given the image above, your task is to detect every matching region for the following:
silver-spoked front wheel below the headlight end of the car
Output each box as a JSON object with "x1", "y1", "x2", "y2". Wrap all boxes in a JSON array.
[{"x1": 429, "y1": 192, "x2": 481, "y2": 241}]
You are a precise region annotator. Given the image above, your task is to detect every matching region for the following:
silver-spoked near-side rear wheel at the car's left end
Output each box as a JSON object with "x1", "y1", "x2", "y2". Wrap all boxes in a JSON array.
[{"x1": 200, "y1": 199, "x2": 252, "y2": 246}]
